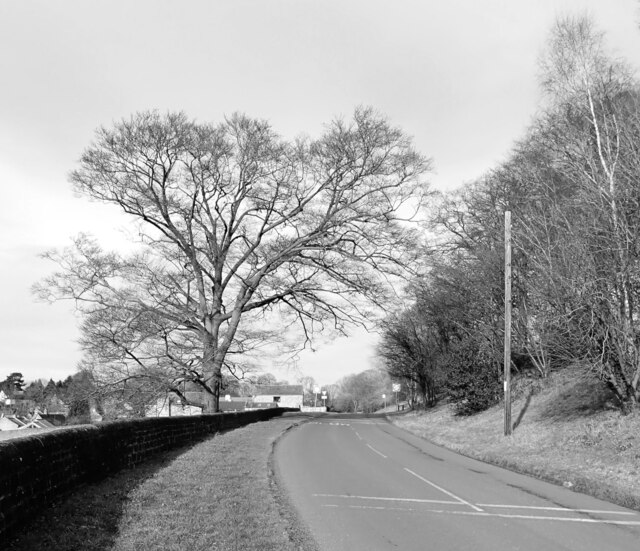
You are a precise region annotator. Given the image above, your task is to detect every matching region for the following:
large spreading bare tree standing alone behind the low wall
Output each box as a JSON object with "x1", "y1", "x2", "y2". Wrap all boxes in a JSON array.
[{"x1": 38, "y1": 108, "x2": 429, "y2": 411}]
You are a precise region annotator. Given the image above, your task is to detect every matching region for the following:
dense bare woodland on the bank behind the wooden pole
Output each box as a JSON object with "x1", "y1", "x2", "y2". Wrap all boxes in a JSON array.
[{"x1": 380, "y1": 18, "x2": 640, "y2": 413}]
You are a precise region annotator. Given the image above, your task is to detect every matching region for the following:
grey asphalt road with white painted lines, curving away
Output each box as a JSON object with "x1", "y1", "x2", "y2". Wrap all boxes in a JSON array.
[{"x1": 275, "y1": 417, "x2": 640, "y2": 551}]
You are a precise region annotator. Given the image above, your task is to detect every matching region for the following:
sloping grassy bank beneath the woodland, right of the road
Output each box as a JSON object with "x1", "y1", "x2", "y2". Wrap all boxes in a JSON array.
[{"x1": 392, "y1": 370, "x2": 640, "y2": 510}]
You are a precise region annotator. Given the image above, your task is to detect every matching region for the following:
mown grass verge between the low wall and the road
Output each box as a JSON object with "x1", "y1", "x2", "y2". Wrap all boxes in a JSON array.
[{"x1": 3, "y1": 418, "x2": 314, "y2": 551}]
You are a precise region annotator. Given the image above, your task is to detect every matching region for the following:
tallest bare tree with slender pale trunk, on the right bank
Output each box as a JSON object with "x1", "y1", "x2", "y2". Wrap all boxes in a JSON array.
[{"x1": 532, "y1": 18, "x2": 640, "y2": 411}]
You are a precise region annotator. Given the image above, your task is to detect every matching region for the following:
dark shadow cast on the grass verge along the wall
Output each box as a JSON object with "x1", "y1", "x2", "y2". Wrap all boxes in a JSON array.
[{"x1": 1, "y1": 445, "x2": 192, "y2": 551}]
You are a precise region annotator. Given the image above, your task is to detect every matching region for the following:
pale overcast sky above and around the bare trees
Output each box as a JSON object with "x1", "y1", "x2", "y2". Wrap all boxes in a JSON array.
[{"x1": 0, "y1": 0, "x2": 640, "y2": 384}]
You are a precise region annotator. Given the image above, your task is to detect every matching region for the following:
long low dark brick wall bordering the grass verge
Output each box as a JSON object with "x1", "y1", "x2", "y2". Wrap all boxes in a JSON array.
[{"x1": 0, "y1": 408, "x2": 286, "y2": 535}]
